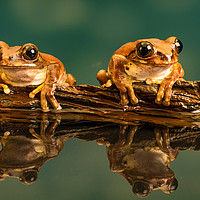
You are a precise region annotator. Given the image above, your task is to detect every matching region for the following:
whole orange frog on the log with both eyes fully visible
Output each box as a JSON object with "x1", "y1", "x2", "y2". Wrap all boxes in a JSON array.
[{"x1": 97, "y1": 37, "x2": 184, "y2": 106}]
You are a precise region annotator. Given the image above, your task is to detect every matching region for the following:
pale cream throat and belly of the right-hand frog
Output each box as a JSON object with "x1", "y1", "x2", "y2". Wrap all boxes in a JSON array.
[{"x1": 125, "y1": 63, "x2": 172, "y2": 81}]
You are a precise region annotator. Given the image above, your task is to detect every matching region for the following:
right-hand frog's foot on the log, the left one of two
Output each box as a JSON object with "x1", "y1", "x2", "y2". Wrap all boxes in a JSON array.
[{"x1": 115, "y1": 81, "x2": 138, "y2": 105}]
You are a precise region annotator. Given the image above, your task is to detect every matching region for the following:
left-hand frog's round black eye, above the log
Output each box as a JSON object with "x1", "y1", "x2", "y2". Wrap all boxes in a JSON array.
[{"x1": 22, "y1": 44, "x2": 39, "y2": 60}]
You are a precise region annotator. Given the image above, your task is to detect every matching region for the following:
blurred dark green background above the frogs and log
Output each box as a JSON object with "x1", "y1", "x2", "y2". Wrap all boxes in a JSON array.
[{"x1": 0, "y1": 0, "x2": 200, "y2": 85}]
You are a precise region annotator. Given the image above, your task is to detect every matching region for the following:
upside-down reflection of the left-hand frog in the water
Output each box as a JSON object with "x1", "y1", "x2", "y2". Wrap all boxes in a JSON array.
[{"x1": 0, "y1": 117, "x2": 67, "y2": 185}]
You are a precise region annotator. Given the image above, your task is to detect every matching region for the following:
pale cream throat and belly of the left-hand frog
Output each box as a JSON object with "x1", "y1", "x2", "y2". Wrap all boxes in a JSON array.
[{"x1": 1, "y1": 67, "x2": 47, "y2": 87}]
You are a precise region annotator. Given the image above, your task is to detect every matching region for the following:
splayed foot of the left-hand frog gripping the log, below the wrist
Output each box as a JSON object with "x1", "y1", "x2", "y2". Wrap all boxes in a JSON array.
[{"x1": 29, "y1": 83, "x2": 62, "y2": 112}]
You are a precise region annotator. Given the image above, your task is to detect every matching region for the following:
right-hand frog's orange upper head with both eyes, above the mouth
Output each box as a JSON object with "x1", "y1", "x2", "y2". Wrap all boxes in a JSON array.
[{"x1": 115, "y1": 37, "x2": 183, "y2": 66}]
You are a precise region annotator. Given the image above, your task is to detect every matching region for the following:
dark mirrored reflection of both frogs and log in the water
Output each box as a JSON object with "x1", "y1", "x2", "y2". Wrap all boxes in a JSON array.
[{"x1": 0, "y1": 112, "x2": 199, "y2": 197}]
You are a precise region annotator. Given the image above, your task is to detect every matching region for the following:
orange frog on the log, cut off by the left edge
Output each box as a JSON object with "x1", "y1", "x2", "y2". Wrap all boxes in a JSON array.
[{"x1": 0, "y1": 41, "x2": 76, "y2": 111}]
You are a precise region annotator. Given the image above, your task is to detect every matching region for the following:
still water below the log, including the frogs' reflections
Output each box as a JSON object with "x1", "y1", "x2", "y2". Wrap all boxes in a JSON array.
[{"x1": 0, "y1": 115, "x2": 200, "y2": 199}]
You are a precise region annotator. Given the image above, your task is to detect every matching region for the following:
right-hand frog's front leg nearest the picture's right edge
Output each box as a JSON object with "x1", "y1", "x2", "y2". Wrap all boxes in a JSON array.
[{"x1": 155, "y1": 63, "x2": 184, "y2": 106}]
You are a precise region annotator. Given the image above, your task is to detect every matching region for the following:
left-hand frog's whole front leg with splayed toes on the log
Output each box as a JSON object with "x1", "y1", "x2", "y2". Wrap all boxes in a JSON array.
[{"x1": 29, "y1": 64, "x2": 62, "y2": 112}]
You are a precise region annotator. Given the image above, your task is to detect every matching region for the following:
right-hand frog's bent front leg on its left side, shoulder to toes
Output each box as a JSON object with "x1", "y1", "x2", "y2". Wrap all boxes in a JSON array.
[{"x1": 109, "y1": 55, "x2": 138, "y2": 105}]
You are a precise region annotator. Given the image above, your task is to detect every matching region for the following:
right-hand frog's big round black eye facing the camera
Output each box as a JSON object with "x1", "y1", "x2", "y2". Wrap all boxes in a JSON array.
[{"x1": 136, "y1": 41, "x2": 154, "y2": 58}]
